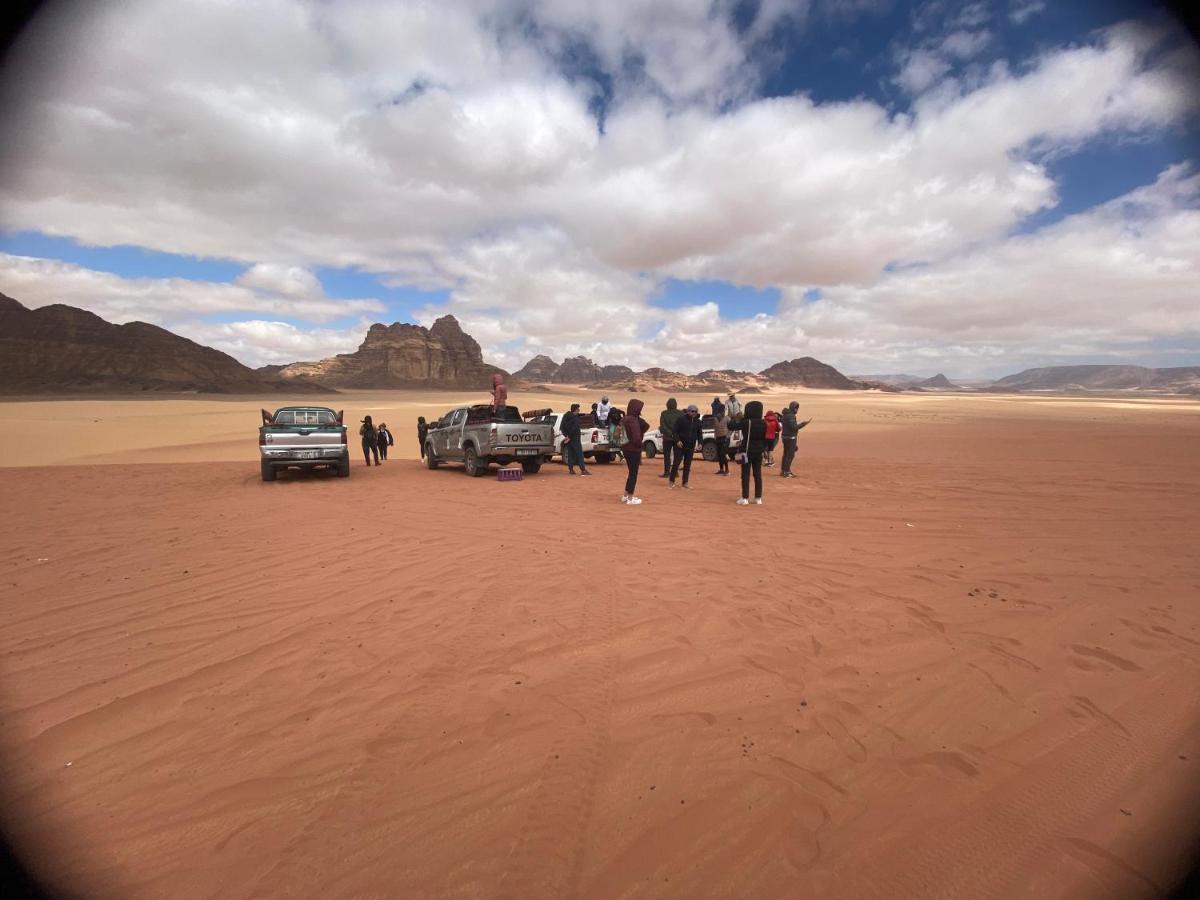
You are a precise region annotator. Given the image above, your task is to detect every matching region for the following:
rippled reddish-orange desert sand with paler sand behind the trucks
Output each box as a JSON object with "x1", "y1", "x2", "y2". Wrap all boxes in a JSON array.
[{"x1": 0, "y1": 392, "x2": 1200, "y2": 899}]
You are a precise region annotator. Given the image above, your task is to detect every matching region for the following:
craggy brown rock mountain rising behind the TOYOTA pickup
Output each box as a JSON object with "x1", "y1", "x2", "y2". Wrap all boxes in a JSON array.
[{"x1": 277, "y1": 316, "x2": 506, "y2": 390}]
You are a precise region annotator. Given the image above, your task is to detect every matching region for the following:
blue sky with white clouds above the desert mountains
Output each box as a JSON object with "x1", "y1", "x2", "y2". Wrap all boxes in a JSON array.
[{"x1": 0, "y1": 0, "x2": 1200, "y2": 378}]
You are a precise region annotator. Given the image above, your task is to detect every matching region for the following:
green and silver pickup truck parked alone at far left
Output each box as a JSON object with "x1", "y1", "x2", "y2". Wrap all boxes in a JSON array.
[{"x1": 258, "y1": 407, "x2": 350, "y2": 481}]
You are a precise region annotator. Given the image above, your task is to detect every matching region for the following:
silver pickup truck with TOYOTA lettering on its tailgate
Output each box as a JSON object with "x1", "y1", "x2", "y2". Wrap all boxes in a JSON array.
[{"x1": 425, "y1": 404, "x2": 554, "y2": 476}]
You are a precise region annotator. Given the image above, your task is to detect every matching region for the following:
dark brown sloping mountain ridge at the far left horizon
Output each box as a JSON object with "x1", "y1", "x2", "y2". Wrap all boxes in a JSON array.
[{"x1": 0, "y1": 294, "x2": 328, "y2": 394}]
